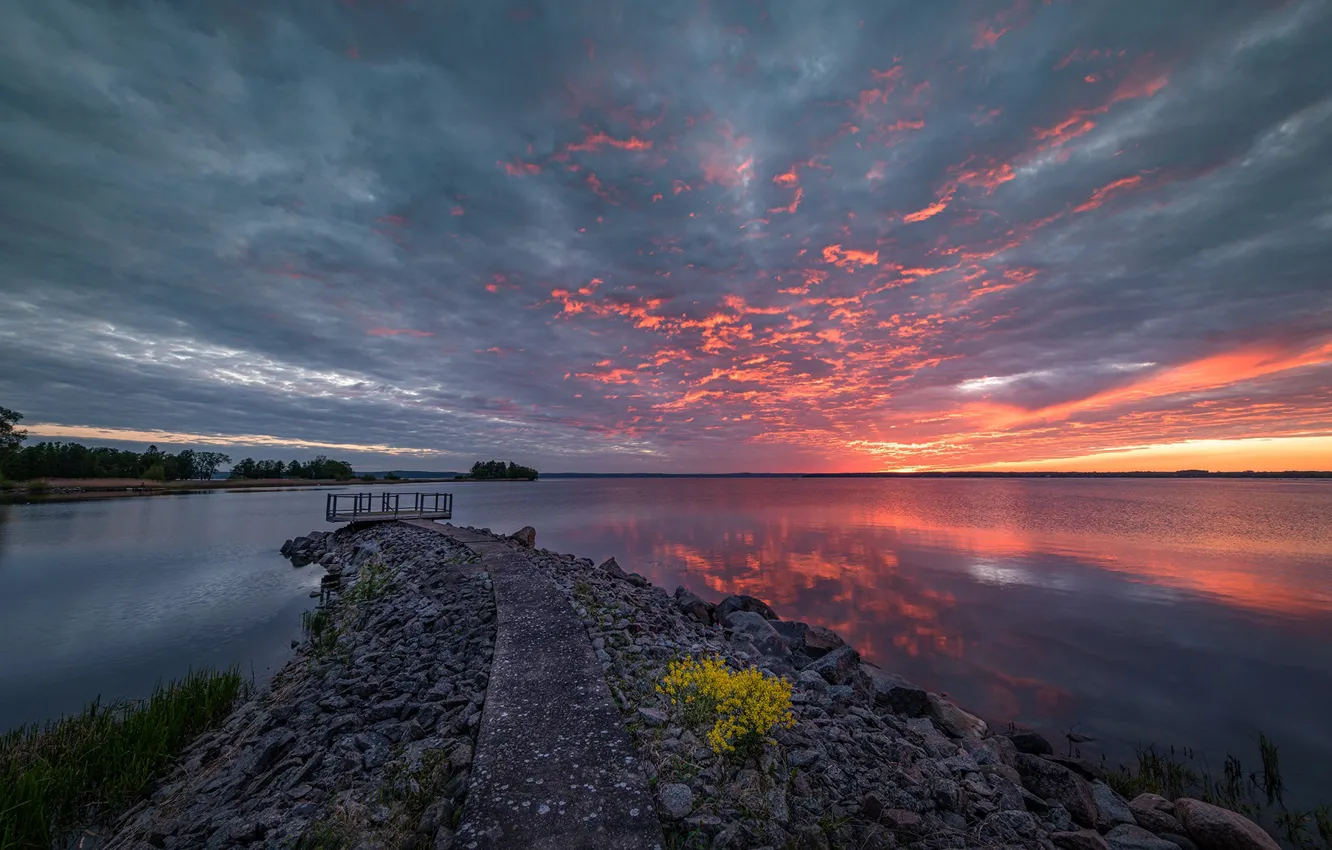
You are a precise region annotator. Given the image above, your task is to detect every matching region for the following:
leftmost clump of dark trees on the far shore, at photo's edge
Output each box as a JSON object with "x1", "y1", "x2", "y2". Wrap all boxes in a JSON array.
[{"x1": 3, "y1": 442, "x2": 232, "y2": 481}]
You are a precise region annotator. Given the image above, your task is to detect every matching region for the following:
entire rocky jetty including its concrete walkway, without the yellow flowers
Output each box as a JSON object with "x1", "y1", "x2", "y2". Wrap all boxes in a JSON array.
[{"x1": 93, "y1": 522, "x2": 1277, "y2": 850}]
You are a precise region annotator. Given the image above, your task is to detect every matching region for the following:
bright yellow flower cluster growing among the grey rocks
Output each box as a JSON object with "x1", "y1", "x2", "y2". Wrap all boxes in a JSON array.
[{"x1": 657, "y1": 658, "x2": 795, "y2": 755}]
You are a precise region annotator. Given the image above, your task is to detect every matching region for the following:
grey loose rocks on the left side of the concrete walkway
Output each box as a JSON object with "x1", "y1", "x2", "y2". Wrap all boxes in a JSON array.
[{"x1": 99, "y1": 525, "x2": 494, "y2": 850}]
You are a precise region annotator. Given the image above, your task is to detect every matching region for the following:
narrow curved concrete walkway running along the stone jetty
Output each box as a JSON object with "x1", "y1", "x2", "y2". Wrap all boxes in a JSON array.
[{"x1": 399, "y1": 521, "x2": 662, "y2": 850}]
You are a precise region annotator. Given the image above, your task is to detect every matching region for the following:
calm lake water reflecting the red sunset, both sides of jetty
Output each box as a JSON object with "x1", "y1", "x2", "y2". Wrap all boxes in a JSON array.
[{"x1": 0, "y1": 478, "x2": 1332, "y2": 803}]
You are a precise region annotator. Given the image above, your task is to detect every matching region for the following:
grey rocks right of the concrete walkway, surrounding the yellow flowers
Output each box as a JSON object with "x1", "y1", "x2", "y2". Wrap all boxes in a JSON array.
[{"x1": 487, "y1": 538, "x2": 1277, "y2": 850}]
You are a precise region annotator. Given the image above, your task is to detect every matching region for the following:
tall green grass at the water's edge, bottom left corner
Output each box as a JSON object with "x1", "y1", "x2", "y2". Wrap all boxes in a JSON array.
[{"x1": 0, "y1": 667, "x2": 246, "y2": 850}]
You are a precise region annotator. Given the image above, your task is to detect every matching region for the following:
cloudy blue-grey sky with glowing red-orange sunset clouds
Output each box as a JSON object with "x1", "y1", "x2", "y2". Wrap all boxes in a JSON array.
[{"x1": 0, "y1": 0, "x2": 1332, "y2": 472}]
